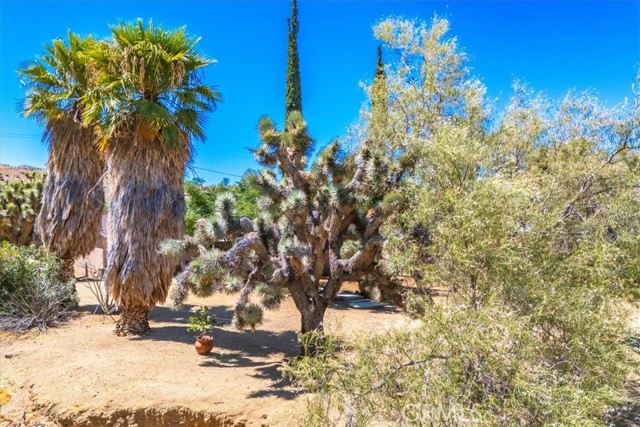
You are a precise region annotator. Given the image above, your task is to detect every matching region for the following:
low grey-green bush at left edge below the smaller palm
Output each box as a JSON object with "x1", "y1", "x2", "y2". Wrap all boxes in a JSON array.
[{"x1": 0, "y1": 242, "x2": 77, "y2": 331}]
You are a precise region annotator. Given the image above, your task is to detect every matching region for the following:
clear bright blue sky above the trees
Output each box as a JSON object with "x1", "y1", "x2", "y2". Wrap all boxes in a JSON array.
[{"x1": 0, "y1": 0, "x2": 640, "y2": 183}]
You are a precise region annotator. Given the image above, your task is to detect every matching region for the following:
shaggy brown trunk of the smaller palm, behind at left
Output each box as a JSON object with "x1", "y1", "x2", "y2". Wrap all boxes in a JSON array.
[{"x1": 37, "y1": 116, "x2": 105, "y2": 279}]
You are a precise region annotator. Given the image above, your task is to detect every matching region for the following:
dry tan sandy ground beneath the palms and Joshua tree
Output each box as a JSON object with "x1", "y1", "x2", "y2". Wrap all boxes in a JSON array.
[{"x1": 0, "y1": 283, "x2": 404, "y2": 427}]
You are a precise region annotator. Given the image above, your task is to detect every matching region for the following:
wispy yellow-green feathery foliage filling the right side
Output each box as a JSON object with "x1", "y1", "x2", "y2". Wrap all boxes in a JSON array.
[{"x1": 288, "y1": 15, "x2": 640, "y2": 426}]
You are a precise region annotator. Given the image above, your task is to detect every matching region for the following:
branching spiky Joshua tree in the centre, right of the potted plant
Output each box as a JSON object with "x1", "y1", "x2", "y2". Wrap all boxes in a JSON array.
[{"x1": 162, "y1": 112, "x2": 410, "y2": 344}]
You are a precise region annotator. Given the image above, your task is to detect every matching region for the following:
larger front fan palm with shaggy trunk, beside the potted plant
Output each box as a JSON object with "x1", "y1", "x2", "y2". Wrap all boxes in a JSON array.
[{"x1": 85, "y1": 20, "x2": 220, "y2": 335}]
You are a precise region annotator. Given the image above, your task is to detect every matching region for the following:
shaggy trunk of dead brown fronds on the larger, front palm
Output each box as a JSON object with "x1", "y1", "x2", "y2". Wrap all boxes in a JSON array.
[{"x1": 105, "y1": 136, "x2": 190, "y2": 335}]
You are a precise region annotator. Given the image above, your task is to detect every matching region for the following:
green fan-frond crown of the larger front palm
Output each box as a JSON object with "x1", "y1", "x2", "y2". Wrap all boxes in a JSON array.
[{"x1": 83, "y1": 19, "x2": 221, "y2": 149}]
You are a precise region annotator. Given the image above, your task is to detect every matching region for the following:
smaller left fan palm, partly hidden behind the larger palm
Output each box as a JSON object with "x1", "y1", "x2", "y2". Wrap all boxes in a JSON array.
[{"x1": 18, "y1": 33, "x2": 105, "y2": 277}]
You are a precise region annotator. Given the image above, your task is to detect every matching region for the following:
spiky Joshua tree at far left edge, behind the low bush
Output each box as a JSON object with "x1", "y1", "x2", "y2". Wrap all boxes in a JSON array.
[{"x1": 0, "y1": 172, "x2": 43, "y2": 245}]
